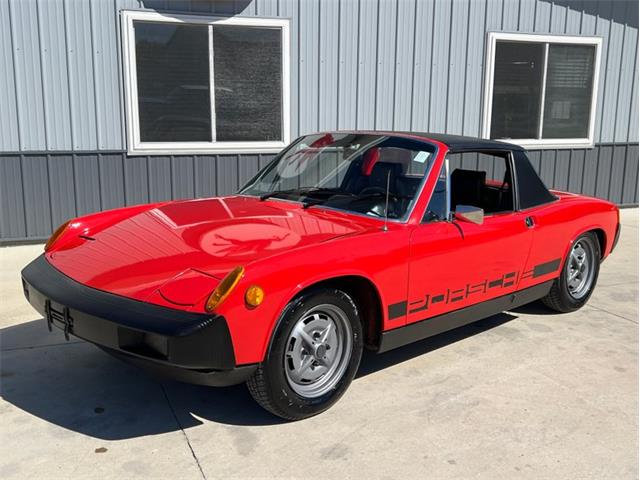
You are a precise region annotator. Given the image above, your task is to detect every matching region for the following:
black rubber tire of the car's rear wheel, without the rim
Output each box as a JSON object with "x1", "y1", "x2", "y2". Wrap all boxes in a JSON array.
[{"x1": 542, "y1": 232, "x2": 601, "y2": 313}]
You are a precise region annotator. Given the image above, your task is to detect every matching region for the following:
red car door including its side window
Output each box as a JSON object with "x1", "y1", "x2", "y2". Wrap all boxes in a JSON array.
[{"x1": 406, "y1": 153, "x2": 532, "y2": 323}]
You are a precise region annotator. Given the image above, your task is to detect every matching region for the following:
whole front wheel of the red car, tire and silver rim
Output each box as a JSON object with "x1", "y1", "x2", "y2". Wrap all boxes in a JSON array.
[{"x1": 247, "y1": 289, "x2": 362, "y2": 420}]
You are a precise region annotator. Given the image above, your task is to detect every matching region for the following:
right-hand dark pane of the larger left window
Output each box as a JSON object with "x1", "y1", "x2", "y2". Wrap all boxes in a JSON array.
[{"x1": 213, "y1": 26, "x2": 282, "y2": 141}]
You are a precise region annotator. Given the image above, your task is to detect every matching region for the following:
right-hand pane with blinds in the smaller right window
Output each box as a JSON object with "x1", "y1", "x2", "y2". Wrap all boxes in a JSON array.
[{"x1": 542, "y1": 45, "x2": 595, "y2": 138}]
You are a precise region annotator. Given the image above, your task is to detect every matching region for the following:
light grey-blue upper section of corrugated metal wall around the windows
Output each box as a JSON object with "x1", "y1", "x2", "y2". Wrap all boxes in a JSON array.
[{"x1": 0, "y1": 0, "x2": 638, "y2": 152}]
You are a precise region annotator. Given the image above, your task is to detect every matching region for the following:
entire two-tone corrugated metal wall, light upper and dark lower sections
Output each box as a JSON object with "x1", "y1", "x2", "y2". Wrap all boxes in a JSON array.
[{"x1": 0, "y1": 0, "x2": 638, "y2": 239}]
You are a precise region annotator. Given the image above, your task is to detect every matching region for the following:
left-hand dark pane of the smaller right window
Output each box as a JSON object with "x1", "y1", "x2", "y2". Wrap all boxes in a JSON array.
[{"x1": 491, "y1": 42, "x2": 544, "y2": 138}]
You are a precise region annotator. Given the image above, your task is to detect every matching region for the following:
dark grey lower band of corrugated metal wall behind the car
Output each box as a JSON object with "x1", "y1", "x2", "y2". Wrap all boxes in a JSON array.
[{"x1": 0, "y1": 144, "x2": 638, "y2": 241}]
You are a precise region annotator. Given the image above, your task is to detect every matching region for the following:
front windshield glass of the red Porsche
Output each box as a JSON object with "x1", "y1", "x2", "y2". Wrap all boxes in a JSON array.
[{"x1": 240, "y1": 133, "x2": 436, "y2": 220}]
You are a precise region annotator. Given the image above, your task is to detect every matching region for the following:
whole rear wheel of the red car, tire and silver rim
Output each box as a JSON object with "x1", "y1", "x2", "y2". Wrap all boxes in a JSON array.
[{"x1": 542, "y1": 232, "x2": 600, "y2": 312}]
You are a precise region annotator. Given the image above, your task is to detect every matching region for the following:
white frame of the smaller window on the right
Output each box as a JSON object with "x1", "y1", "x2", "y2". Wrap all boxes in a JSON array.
[{"x1": 482, "y1": 32, "x2": 602, "y2": 149}]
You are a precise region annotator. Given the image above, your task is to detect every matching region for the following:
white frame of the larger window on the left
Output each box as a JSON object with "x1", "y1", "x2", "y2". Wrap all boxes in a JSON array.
[{"x1": 121, "y1": 10, "x2": 291, "y2": 155}]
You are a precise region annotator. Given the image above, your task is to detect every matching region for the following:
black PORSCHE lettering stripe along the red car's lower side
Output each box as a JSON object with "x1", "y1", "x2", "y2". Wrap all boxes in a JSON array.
[{"x1": 388, "y1": 258, "x2": 562, "y2": 320}]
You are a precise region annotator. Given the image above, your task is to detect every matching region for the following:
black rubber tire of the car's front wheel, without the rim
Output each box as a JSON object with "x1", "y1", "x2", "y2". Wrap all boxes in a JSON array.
[{"x1": 247, "y1": 288, "x2": 363, "y2": 420}]
